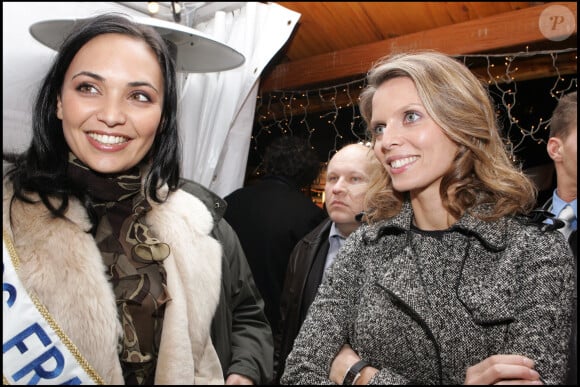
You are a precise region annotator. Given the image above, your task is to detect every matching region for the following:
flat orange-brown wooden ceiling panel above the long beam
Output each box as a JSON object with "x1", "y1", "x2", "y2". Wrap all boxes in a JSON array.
[{"x1": 278, "y1": 1, "x2": 542, "y2": 62}]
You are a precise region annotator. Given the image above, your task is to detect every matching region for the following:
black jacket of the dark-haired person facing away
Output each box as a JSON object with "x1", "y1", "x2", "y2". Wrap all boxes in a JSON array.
[{"x1": 225, "y1": 177, "x2": 325, "y2": 342}]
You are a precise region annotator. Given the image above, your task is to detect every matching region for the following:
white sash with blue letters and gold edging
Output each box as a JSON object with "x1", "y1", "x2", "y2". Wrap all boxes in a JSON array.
[{"x1": 2, "y1": 230, "x2": 104, "y2": 385}]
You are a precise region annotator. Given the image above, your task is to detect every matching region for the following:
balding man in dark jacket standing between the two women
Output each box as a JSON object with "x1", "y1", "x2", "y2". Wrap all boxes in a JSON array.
[{"x1": 274, "y1": 144, "x2": 380, "y2": 384}]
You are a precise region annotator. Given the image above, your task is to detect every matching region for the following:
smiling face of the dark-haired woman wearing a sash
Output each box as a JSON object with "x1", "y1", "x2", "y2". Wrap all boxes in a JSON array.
[{"x1": 57, "y1": 33, "x2": 164, "y2": 173}]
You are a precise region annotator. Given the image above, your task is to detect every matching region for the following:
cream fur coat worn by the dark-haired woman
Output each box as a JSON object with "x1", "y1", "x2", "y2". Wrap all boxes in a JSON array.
[{"x1": 3, "y1": 179, "x2": 223, "y2": 385}]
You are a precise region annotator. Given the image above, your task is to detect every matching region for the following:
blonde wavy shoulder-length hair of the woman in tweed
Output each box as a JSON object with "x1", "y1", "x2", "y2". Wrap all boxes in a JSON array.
[{"x1": 359, "y1": 51, "x2": 537, "y2": 223}]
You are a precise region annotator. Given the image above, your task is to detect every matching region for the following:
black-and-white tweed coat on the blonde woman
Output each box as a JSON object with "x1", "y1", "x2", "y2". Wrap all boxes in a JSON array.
[{"x1": 281, "y1": 203, "x2": 576, "y2": 384}]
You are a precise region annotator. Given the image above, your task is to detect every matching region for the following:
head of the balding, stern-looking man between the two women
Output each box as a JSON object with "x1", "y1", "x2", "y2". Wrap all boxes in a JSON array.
[{"x1": 324, "y1": 144, "x2": 379, "y2": 237}]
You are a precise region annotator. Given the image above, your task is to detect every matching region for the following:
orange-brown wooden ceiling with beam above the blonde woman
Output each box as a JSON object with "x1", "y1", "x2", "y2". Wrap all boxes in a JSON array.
[{"x1": 260, "y1": 2, "x2": 577, "y2": 92}]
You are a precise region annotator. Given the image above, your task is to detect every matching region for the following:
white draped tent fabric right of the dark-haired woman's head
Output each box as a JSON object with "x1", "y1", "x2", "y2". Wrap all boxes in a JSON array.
[{"x1": 180, "y1": 2, "x2": 300, "y2": 196}]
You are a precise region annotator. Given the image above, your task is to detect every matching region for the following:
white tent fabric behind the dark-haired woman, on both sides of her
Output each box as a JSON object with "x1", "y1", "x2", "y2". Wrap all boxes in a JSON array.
[{"x1": 2, "y1": 2, "x2": 300, "y2": 200}]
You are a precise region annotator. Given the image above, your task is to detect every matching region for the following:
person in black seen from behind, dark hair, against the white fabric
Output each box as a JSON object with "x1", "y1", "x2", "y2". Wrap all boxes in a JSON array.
[{"x1": 225, "y1": 136, "x2": 325, "y2": 346}]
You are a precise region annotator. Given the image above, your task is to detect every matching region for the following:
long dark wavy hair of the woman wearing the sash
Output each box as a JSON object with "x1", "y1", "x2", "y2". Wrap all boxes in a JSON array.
[{"x1": 3, "y1": 13, "x2": 181, "y2": 217}]
